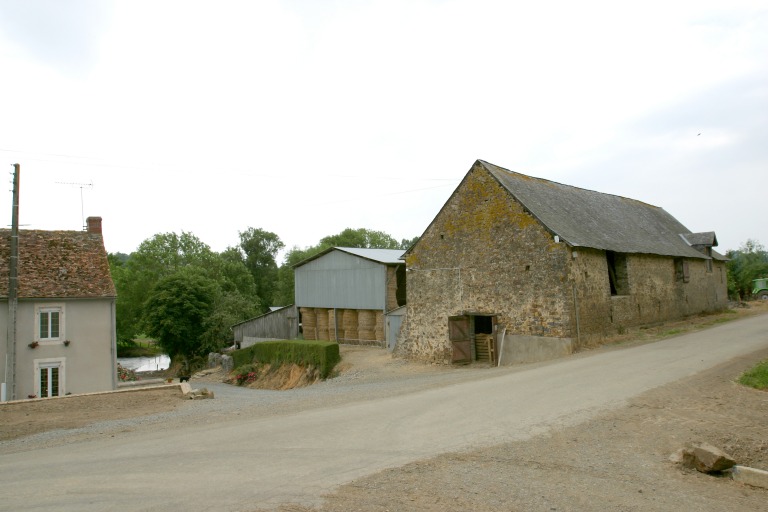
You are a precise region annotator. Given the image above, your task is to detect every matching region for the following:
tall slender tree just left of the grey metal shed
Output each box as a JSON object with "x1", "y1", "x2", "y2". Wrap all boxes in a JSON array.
[{"x1": 240, "y1": 228, "x2": 285, "y2": 311}]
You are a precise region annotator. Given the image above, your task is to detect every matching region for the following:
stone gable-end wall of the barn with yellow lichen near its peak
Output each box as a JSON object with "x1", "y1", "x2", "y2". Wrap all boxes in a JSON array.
[{"x1": 397, "y1": 165, "x2": 571, "y2": 363}]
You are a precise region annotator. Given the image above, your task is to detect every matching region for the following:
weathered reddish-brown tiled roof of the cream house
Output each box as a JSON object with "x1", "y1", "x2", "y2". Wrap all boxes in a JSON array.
[{"x1": 0, "y1": 229, "x2": 117, "y2": 299}]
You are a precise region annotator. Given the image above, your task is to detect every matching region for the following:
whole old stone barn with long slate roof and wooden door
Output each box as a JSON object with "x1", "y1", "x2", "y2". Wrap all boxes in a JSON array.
[{"x1": 396, "y1": 160, "x2": 727, "y2": 364}]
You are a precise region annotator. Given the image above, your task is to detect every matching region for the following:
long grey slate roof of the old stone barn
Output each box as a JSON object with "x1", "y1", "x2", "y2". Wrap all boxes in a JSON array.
[{"x1": 475, "y1": 160, "x2": 725, "y2": 259}]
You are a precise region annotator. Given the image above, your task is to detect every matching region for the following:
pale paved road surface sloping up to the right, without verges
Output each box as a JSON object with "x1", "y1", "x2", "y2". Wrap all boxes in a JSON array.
[{"x1": 0, "y1": 315, "x2": 768, "y2": 512}]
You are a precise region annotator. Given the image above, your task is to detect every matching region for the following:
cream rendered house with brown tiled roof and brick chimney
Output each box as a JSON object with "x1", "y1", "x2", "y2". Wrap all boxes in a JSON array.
[{"x1": 0, "y1": 217, "x2": 117, "y2": 399}]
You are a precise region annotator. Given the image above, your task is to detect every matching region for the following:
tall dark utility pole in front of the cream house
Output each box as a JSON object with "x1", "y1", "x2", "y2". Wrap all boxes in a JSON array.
[{"x1": 3, "y1": 164, "x2": 21, "y2": 400}]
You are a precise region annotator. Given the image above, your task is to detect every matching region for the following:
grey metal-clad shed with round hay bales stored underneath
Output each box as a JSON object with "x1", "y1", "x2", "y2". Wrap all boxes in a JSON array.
[{"x1": 294, "y1": 247, "x2": 405, "y2": 347}]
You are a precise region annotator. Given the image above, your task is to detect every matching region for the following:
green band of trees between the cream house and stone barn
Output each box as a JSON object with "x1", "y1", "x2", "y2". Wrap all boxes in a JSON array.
[{"x1": 108, "y1": 227, "x2": 418, "y2": 358}]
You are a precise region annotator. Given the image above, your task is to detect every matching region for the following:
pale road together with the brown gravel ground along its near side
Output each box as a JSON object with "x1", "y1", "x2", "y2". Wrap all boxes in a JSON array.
[{"x1": 0, "y1": 310, "x2": 768, "y2": 511}]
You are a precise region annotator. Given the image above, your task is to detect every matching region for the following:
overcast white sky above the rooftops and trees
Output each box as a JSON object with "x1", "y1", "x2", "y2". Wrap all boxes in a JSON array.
[{"x1": 0, "y1": 0, "x2": 768, "y2": 263}]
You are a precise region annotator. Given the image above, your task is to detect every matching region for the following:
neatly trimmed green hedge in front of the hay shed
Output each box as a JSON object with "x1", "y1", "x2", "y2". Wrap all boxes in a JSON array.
[{"x1": 232, "y1": 340, "x2": 341, "y2": 379}]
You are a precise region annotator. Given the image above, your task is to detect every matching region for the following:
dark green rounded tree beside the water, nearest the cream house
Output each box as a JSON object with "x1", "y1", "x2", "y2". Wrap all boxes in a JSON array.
[{"x1": 142, "y1": 268, "x2": 220, "y2": 359}]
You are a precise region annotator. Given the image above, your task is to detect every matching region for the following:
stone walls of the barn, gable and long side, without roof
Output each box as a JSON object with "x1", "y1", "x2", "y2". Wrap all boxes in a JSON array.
[{"x1": 395, "y1": 167, "x2": 727, "y2": 364}]
